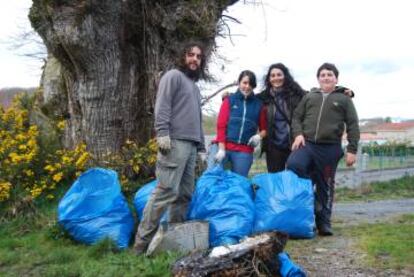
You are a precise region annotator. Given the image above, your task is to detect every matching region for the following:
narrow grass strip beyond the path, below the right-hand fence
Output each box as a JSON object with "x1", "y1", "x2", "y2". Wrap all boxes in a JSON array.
[{"x1": 335, "y1": 176, "x2": 414, "y2": 202}]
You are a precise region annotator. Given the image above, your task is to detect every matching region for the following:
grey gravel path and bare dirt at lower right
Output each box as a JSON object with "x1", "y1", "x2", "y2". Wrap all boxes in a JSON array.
[{"x1": 290, "y1": 199, "x2": 414, "y2": 277}]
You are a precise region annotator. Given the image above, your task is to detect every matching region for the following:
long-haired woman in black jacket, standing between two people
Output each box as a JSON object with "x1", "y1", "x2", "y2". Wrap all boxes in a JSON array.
[{"x1": 257, "y1": 63, "x2": 306, "y2": 172}]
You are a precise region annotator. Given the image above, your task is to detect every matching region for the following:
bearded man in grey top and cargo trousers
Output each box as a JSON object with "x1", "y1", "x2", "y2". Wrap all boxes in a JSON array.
[{"x1": 134, "y1": 42, "x2": 207, "y2": 255}]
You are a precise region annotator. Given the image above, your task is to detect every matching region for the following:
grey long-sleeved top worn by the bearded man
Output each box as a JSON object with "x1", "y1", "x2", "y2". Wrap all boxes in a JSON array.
[{"x1": 154, "y1": 69, "x2": 205, "y2": 151}]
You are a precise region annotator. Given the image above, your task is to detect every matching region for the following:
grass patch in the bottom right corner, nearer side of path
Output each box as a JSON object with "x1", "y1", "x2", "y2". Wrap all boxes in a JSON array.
[{"x1": 351, "y1": 215, "x2": 414, "y2": 269}]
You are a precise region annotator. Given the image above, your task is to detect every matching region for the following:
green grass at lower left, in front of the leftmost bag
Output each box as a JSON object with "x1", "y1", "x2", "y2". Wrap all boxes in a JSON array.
[{"x1": 0, "y1": 206, "x2": 178, "y2": 276}]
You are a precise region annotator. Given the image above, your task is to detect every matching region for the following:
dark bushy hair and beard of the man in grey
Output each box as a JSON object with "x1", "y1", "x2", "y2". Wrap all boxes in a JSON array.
[{"x1": 177, "y1": 41, "x2": 209, "y2": 81}]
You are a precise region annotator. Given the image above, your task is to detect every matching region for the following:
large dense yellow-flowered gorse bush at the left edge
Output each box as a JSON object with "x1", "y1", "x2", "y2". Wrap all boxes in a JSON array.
[{"x1": 0, "y1": 97, "x2": 90, "y2": 209}]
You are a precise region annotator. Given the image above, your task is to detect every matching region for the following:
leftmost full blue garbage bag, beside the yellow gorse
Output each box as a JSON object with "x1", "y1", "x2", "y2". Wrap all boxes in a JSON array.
[{"x1": 58, "y1": 168, "x2": 134, "y2": 249}]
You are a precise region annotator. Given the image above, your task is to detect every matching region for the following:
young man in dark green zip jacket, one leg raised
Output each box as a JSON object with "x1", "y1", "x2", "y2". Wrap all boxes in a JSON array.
[{"x1": 287, "y1": 63, "x2": 360, "y2": 236}]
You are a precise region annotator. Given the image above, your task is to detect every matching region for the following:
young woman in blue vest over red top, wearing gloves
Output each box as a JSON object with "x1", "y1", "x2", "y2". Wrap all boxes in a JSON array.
[{"x1": 209, "y1": 70, "x2": 266, "y2": 177}]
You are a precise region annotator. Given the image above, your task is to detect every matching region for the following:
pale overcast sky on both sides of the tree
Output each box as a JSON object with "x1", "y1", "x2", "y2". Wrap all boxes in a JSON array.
[{"x1": 0, "y1": 0, "x2": 414, "y2": 118}]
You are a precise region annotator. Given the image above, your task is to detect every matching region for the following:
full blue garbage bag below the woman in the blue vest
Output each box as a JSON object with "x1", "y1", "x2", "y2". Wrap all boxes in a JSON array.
[{"x1": 188, "y1": 166, "x2": 254, "y2": 247}]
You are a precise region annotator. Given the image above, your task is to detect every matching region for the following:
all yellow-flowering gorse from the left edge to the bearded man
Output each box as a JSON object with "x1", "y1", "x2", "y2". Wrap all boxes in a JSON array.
[{"x1": 0, "y1": 92, "x2": 157, "y2": 213}]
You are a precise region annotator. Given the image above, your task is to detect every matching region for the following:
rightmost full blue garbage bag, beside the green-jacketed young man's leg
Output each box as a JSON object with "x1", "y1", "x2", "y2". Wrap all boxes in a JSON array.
[{"x1": 252, "y1": 170, "x2": 315, "y2": 238}]
